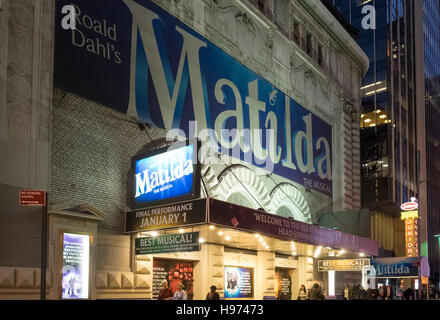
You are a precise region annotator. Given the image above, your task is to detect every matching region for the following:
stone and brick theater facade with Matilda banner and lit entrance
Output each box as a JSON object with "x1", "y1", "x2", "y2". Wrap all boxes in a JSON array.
[{"x1": 0, "y1": 0, "x2": 378, "y2": 299}]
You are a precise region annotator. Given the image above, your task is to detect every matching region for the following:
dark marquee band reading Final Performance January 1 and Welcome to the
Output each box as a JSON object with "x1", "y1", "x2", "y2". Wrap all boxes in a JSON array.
[{"x1": 125, "y1": 198, "x2": 379, "y2": 256}]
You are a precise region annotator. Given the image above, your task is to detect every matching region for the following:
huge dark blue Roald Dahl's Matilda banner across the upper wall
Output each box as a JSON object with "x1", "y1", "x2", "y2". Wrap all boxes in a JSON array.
[{"x1": 54, "y1": 0, "x2": 332, "y2": 196}]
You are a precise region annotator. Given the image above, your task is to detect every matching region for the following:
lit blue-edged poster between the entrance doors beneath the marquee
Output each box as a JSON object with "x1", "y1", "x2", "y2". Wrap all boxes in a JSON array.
[{"x1": 225, "y1": 267, "x2": 254, "y2": 299}]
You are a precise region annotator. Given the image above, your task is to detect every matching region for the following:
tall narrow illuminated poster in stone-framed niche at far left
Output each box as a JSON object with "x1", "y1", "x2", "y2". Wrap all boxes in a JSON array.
[{"x1": 61, "y1": 232, "x2": 90, "y2": 299}]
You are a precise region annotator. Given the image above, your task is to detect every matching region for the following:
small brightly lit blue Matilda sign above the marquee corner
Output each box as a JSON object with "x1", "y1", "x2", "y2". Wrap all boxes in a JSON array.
[{"x1": 133, "y1": 144, "x2": 197, "y2": 207}]
